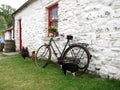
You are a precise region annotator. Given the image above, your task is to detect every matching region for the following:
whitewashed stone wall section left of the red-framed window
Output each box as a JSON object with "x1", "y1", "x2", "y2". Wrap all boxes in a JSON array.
[{"x1": 15, "y1": 0, "x2": 58, "y2": 52}]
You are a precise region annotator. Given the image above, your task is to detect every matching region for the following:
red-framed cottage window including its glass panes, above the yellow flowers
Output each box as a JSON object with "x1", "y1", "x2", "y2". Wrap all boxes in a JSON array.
[{"x1": 48, "y1": 4, "x2": 58, "y2": 36}]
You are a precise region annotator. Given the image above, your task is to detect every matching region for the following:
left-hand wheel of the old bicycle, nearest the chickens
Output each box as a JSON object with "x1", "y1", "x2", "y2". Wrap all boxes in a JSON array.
[{"x1": 36, "y1": 44, "x2": 51, "y2": 68}]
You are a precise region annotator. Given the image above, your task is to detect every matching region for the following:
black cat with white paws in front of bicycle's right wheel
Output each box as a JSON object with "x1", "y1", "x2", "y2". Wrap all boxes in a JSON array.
[{"x1": 58, "y1": 61, "x2": 79, "y2": 76}]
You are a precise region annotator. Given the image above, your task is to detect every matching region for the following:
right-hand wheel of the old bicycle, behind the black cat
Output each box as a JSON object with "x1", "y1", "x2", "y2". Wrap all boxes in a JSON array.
[{"x1": 63, "y1": 44, "x2": 91, "y2": 75}]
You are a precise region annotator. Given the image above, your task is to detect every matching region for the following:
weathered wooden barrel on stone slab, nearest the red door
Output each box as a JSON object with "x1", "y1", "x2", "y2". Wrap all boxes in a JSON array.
[{"x1": 4, "y1": 40, "x2": 16, "y2": 53}]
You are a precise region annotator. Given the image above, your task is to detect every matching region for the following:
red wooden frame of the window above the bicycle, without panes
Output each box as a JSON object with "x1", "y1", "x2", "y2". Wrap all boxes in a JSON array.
[{"x1": 48, "y1": 4, "x2": 58, "y2": 36}]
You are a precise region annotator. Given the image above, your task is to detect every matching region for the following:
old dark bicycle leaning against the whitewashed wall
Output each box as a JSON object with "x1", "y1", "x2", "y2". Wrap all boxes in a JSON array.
[{"x1": 36, "y1": 35, "x2": 91, "y2": 74}]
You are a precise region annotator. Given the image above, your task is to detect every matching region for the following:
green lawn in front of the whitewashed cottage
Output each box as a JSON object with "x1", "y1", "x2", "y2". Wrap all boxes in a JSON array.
[{"x1": 0, "y1": 55, "x2": 120, "y2": 90}]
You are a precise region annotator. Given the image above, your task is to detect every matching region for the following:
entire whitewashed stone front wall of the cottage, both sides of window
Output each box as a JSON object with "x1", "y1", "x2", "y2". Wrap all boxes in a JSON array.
[{"x1": 15, "y1": 0, "x2": 120, "y2": 79}]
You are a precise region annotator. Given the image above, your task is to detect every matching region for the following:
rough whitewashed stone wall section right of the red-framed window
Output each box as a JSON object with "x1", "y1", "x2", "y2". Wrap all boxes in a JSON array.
[{"x1": 59, "y1": 0, "x2": 120, "y2": 79}]
